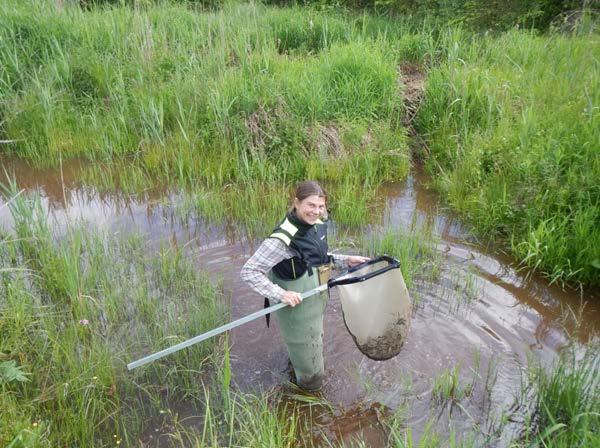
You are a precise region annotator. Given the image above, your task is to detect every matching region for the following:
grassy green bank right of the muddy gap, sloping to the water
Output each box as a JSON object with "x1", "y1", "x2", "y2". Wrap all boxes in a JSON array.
[{"x1": 418, "y1": 31, "x2": 600, "y2": 285}]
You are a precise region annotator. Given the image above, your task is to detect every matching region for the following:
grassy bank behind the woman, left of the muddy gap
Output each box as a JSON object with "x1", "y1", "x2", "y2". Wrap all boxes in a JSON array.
[{"x1": 0, "y1": 1, "x2": 411, "y2": 200}]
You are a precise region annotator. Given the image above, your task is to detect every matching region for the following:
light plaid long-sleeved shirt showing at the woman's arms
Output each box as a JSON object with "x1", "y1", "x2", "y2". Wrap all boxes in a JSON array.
[{"x1": 240, "y1": 238, "x2": 349, "y2": 303}]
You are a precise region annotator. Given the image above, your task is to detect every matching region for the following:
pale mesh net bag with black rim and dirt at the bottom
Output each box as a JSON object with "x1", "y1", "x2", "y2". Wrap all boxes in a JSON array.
[{"x1": 329, "y1": 256, "x2": 411, "y2": 361}]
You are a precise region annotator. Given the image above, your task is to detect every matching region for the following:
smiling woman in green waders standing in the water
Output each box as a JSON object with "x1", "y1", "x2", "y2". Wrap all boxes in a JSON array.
[{"x1": 240, "y1": 181, "x2": 368, "y2": 391}]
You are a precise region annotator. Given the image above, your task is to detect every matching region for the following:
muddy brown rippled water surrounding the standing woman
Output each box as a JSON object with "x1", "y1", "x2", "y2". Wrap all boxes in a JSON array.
[{"x1": 0, "y1": 159, "x2": 600, "y2": 447}]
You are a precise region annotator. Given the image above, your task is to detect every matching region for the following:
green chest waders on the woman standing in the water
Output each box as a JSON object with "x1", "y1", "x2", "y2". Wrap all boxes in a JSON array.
[{"x1": 268, "y1": 268, "x2": 329, "y2": 391}]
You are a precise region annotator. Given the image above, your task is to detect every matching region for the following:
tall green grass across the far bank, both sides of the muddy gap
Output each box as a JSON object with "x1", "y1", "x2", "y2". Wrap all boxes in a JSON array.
[{"x1": 0, "y1": 1, "x2": 600, "y2": 285}]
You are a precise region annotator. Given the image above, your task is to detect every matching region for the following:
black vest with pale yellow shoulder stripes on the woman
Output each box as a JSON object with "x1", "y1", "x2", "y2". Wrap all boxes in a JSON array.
[{"x1": 270, "y1": 212, "x2": 330, "y2": 280}]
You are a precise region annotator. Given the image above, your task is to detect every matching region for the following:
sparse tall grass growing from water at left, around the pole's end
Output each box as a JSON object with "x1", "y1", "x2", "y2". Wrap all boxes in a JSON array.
[{"x1": 0, "y1": 185, "x2": 223, "y2": 446}]
